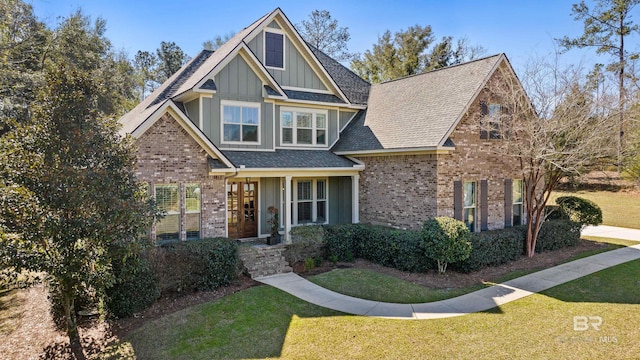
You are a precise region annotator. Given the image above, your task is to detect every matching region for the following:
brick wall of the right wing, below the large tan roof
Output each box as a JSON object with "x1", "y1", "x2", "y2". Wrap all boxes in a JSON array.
[{"x1": 359, "y1": 67, "x2": 521, "y2": 229}]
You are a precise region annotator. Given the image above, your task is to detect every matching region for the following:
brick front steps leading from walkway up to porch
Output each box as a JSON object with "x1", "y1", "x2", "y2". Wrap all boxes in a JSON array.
[{"x1": 240, "y1": 245, "x2": 293, "y2": 279}]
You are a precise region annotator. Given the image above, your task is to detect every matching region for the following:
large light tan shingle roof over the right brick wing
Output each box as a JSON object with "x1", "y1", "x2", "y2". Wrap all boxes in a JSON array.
[{"x1": 332, "y1": 54, "x2": 508, "y2": 153}]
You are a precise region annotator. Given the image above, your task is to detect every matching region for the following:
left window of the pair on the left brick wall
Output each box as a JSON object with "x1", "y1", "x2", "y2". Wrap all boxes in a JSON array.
[{"x1": 155, "y1": 184, "x2": 180, "y2": 241}]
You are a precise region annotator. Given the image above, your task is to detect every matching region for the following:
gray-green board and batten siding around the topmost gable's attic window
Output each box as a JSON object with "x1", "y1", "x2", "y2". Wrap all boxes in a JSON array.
[{"x1": 247, "y1": 31, "x2": 327, "y2": 90}]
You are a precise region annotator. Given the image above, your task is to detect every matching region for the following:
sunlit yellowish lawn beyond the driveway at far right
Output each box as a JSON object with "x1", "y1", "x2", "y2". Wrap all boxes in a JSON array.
[{"x1": 549, "y1": 191, "x2": 640, "y2": 229}]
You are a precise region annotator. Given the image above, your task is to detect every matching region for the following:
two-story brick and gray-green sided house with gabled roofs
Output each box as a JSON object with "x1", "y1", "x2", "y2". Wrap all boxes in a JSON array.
[{"x1": 120, "y1": 9, "x2": 522, "y2": 241}]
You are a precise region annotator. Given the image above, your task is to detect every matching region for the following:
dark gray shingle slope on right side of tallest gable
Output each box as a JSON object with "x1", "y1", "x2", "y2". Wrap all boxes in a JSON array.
[{"x1": 307, "y1": 43, "x2": 371, "y2": 104}]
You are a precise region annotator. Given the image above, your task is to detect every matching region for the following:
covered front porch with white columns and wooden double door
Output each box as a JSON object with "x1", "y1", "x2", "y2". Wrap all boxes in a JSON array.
[{"x1": 219, "y1": 150, "x2": 364, "y2": 243}]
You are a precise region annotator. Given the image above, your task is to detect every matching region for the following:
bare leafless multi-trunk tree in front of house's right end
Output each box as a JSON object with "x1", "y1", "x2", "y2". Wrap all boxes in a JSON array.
[{"x1": 481, "y1": 56, "x2": 616, "y2": 257}]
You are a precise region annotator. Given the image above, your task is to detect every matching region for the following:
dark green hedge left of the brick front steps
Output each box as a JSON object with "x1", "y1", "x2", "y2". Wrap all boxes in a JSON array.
[{"x1": 148, "y1": 238, "x2": 240, "y2": 293}]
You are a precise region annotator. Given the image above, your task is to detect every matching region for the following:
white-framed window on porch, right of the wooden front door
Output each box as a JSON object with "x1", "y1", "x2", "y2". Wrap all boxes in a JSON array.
[{"x1": 291, "y1": 179, "x2": 327, "y2": 225}]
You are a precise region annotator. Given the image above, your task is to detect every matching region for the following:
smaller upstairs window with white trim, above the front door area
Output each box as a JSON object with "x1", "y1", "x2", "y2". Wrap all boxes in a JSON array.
[{"x1": 222, "y1": 101, "x2": 260, "y2": 145}]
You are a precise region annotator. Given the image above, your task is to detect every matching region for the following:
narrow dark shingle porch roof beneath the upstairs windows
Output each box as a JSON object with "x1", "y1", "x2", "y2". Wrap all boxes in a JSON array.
[{"x1": 222, "y1": 149, "x2": 356, "y2": 169}]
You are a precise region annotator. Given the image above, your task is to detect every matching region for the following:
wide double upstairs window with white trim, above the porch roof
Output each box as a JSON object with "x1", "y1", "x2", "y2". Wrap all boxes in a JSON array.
[{"x1": 280, "y1": 108, "x2": 327, "y2": 146}]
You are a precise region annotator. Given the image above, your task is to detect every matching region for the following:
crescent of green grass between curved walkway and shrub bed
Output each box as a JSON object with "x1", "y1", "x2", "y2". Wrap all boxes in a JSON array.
[{"x1": 309, "y1": 269, "x2": 485, "y2": 304}]
